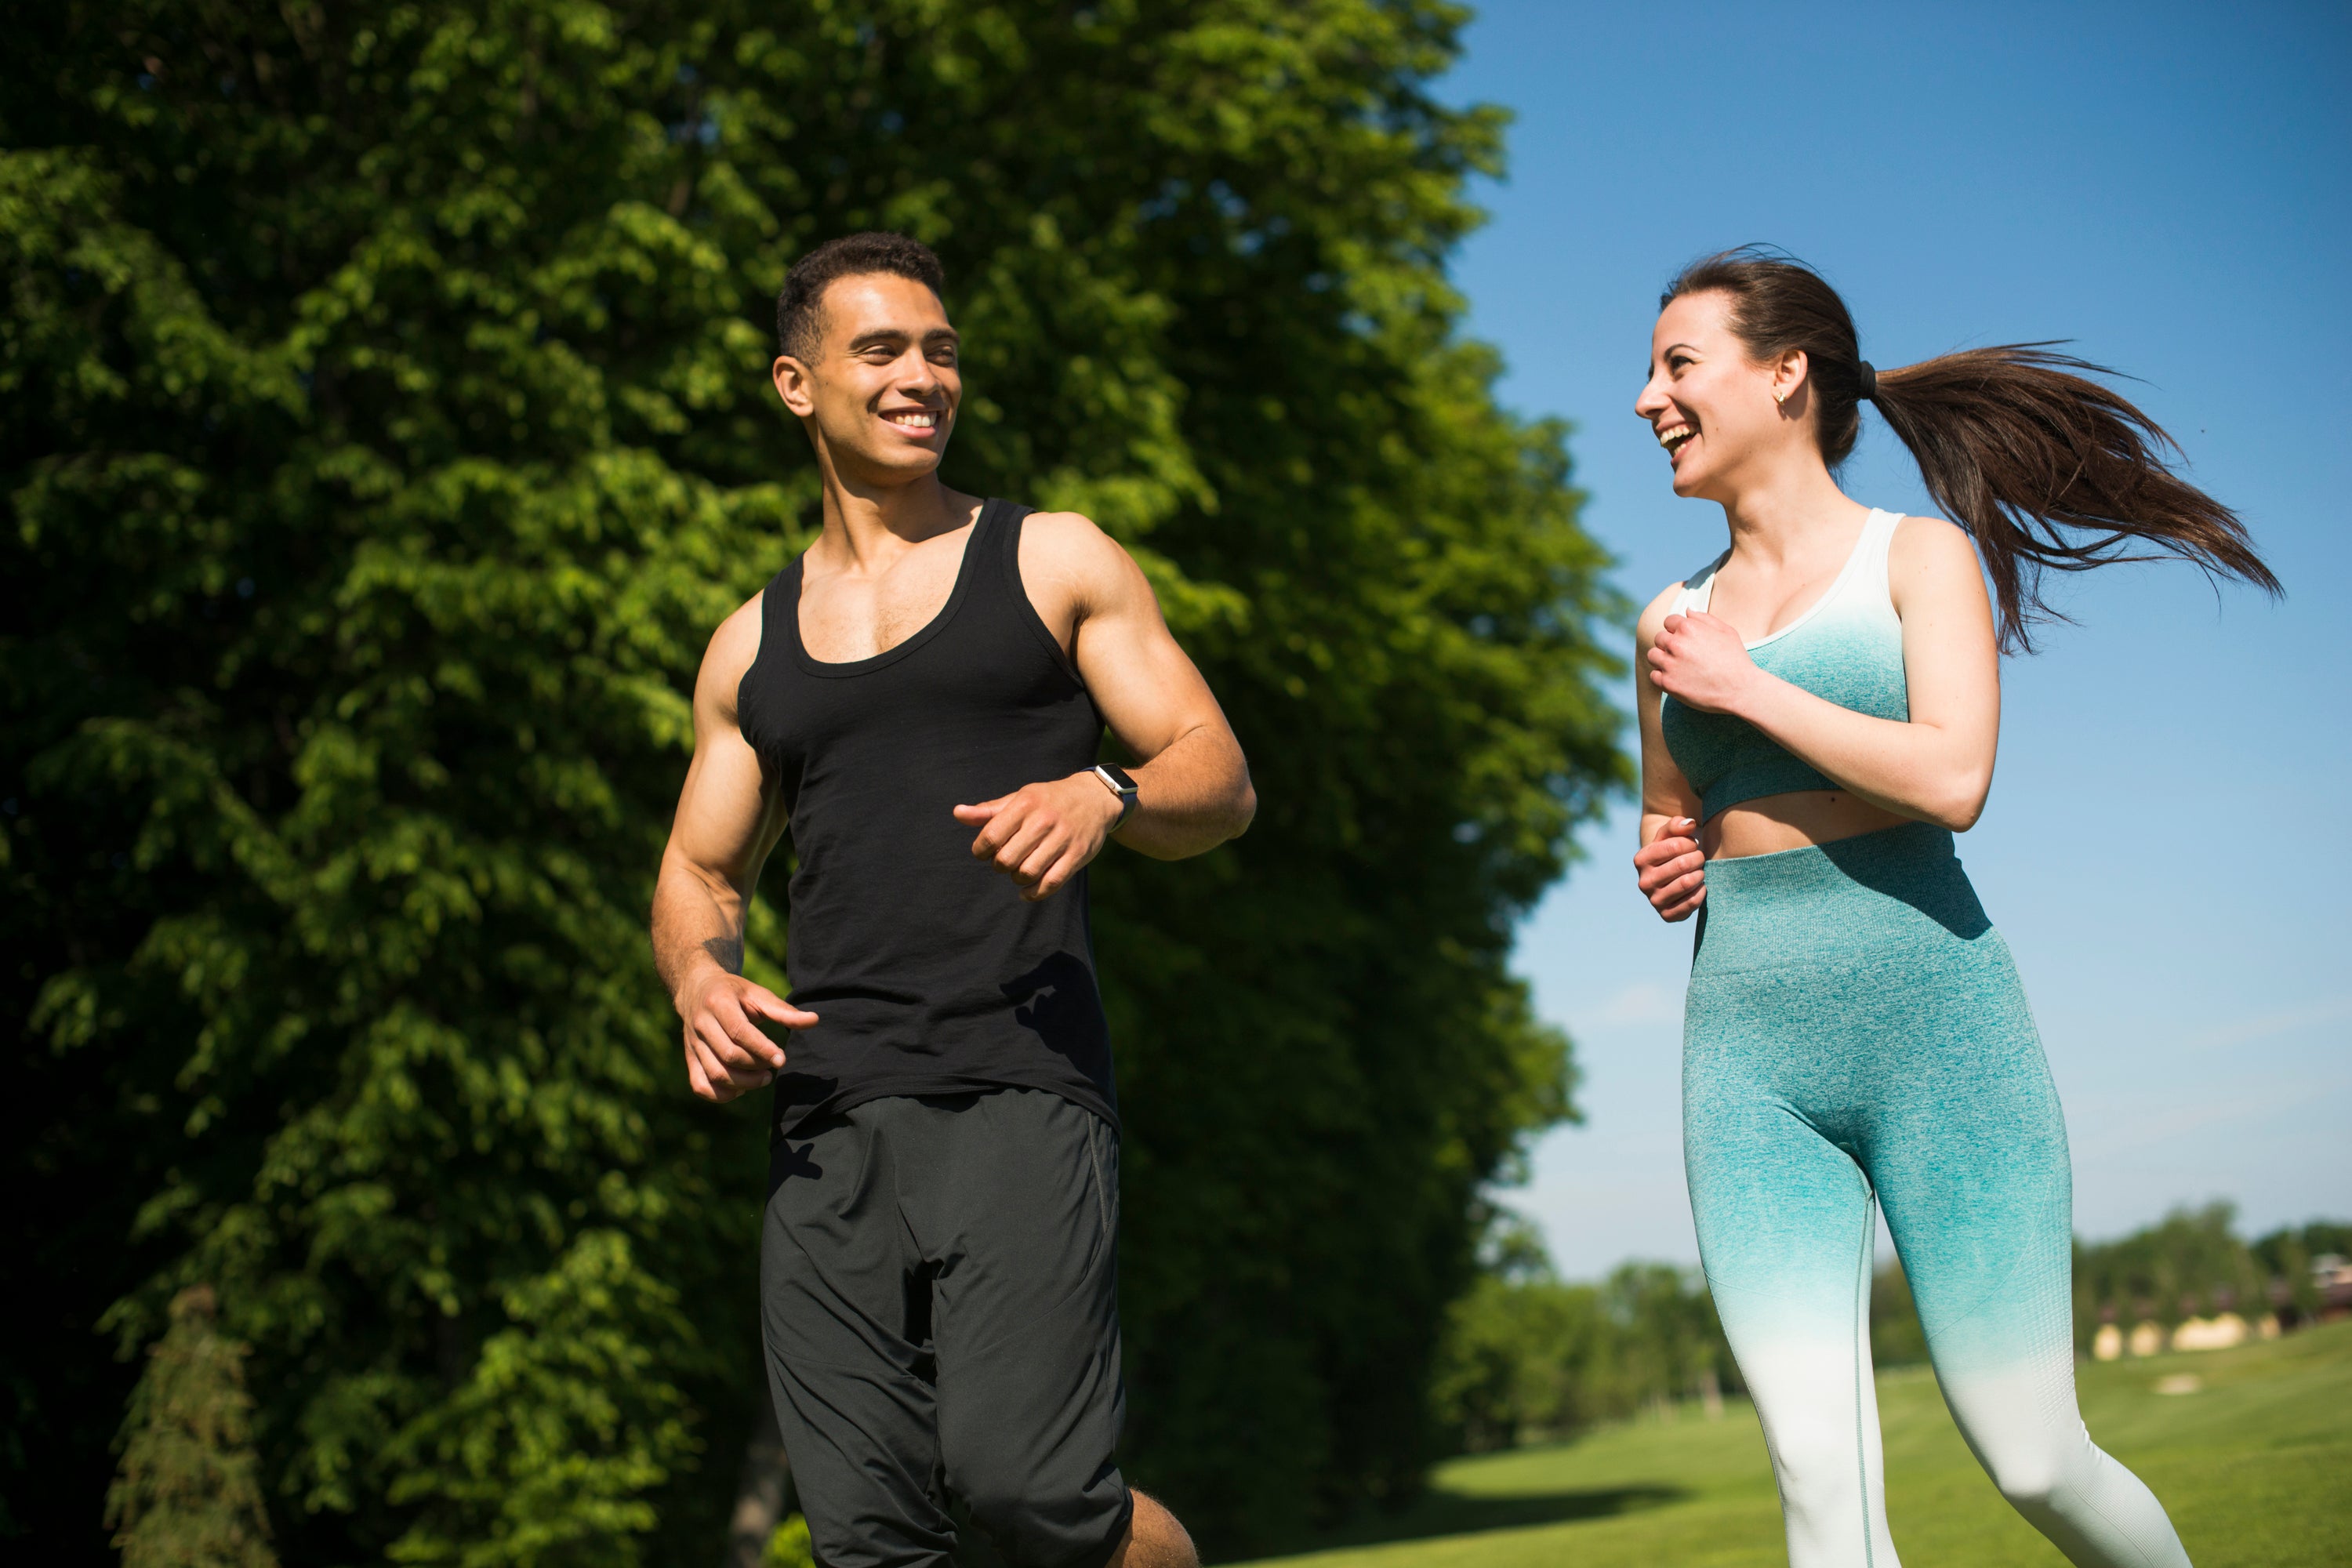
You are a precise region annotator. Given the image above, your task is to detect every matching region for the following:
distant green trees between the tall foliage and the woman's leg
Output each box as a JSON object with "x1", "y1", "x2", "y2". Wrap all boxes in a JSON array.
[{"x1": 1430, "y1": 1227, "x2": 1738, "y2": 1453}]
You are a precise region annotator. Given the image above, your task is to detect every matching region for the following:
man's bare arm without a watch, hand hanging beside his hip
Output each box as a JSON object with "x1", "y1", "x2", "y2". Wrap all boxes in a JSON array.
[{"x1": 654, "y1": 600, "x2": 816, "y2": 1100}]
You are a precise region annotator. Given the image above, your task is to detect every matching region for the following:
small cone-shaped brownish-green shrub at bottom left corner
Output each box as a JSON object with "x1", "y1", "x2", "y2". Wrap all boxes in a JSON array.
[{"x1": 106, "y1": 1286, "x2": 278, "y2": 1568}]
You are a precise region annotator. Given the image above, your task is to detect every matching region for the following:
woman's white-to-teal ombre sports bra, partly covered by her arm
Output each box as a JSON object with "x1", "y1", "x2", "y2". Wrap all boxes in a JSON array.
[{"x1": 1658, "y1": 510, "x2": 1910, "y2": 820}]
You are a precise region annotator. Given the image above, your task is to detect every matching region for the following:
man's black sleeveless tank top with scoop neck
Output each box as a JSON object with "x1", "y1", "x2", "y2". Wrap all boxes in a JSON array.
[{"x1": 736, "y1": 501, "x2": 1117, "y2": 1138}]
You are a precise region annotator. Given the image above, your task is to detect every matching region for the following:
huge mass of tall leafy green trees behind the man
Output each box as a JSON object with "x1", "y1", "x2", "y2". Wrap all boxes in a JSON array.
[{"x1": 0, "y1": 0, "x2": 1623, "y2": 1568}]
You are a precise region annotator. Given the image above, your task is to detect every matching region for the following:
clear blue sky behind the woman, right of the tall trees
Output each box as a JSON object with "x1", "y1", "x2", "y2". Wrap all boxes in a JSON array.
[{"x1": 1442, "y1": 0, "x2": 2352, "y2": 1276}]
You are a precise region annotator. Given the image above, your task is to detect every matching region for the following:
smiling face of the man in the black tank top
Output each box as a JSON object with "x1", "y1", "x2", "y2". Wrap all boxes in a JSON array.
[{"x1": 776, "y1": 273, "x2": 964, "y2": 487}]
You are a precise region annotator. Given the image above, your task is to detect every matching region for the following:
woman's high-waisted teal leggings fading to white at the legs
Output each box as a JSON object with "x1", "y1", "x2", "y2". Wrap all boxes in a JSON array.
[{"x1": 1682, "y1": 822, "x2": 2190, "y2": 1568}]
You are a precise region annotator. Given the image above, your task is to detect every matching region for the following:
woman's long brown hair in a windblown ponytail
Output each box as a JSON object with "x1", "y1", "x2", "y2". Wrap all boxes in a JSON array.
[{"x1": 1658, "y1": 245, "x2": 2279, "y2": 652}]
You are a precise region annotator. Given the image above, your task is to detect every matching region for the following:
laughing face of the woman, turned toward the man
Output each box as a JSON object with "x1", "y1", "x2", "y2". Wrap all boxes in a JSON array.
[{"x1": 1632, "y1": 294, "x2": 1811, "y2": 501}]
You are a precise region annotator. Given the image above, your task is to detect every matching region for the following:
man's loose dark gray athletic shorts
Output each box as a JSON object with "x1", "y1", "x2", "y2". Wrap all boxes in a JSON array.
[{"x1": 760, "y1": 1088, "x2": 1134, "y2": 1568}]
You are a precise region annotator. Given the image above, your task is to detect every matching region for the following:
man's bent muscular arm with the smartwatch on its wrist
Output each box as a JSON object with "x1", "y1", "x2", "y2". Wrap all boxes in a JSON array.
[{"x1": 955, "y1": 513, "x2": 1258, "y2": 900}]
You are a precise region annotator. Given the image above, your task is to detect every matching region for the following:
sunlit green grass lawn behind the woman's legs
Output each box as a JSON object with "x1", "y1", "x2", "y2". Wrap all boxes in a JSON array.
[{"x1": 1232, "y1": 1323, "x2": 2352, "y2": 1568}]
